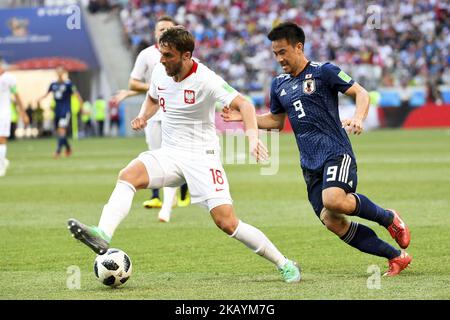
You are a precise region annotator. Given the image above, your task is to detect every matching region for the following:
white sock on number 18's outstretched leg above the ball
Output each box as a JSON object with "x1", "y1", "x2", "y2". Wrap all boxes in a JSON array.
[{"x1": 98, "y1": 180, "x2": 136, "y2": 237}]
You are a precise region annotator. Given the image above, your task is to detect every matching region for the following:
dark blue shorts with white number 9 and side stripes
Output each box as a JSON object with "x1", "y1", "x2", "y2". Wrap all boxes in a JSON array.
[{"x1": 302, "y1": 154, "x2": 358, "y2": 219}]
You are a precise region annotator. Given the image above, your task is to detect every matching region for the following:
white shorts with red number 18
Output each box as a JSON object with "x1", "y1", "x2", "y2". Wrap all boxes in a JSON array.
[{"x1": 137, "y1": 147, "x2": 233, "y2": 210}]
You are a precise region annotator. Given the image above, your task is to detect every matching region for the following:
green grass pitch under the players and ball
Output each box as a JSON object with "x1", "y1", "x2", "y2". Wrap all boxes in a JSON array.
[{"x1": 0, "y1": 129, "x2": 450, "y2": 300}]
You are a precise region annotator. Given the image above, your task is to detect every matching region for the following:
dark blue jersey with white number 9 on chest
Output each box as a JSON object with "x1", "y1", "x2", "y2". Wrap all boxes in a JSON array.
[{"x1": 270, "y1": 62, "x2": 355, "y2": 170}]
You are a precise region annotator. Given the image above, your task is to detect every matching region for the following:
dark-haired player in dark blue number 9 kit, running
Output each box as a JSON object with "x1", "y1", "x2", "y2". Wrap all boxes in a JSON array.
[{"x1": 223, "y1": 22, "x2": 412, "y2": 276}]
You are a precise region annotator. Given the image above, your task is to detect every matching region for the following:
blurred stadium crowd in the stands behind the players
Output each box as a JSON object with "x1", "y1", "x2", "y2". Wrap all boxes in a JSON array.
[{"x1": 113, "y1": 0, "x2": 450, "y2": 101}]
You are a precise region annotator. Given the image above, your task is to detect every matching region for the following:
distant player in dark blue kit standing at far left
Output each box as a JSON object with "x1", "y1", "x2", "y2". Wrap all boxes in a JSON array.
[{"x1": 39, "y1": 67, "x2": 83, "y2": 159}]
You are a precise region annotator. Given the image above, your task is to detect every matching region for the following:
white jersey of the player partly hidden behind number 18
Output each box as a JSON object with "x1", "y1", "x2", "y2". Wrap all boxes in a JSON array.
[{"x1": 130, "y1": 45, "x2": 161, "y2": 121}]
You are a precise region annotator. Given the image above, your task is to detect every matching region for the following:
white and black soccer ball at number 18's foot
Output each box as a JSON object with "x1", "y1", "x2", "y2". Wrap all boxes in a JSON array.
[{"x1": 94, "y1": 248, "x2": 132, "y2": 287}]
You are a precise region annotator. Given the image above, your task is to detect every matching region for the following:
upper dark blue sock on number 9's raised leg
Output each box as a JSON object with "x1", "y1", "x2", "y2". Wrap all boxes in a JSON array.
[{"x1": 353, "y1": 193, "x2": 394, "y2": 228}]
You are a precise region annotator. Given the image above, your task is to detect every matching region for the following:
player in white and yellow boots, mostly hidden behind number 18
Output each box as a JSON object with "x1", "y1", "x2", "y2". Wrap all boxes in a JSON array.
[{"x1": 112, "y1": 16, "x2": 190, "y2": 222}]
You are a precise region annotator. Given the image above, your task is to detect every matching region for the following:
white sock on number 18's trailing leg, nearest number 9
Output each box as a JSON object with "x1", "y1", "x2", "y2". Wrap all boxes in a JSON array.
[{"x1": 230, "y1": 220, "x2": 287, "y2": 268}]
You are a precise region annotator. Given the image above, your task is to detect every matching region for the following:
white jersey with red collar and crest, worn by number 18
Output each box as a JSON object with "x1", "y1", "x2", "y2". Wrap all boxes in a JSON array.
[{"x1": 148, "y1": 60, "x2": 239, "y2": 152}]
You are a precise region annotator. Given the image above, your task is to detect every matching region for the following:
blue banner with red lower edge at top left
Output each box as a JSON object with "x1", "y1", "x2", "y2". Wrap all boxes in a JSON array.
[{"x1": 0, "y1": 5, "x2": 99, "y2": 71}]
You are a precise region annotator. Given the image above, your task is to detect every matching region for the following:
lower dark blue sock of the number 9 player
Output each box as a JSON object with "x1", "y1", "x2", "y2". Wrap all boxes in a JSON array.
[{"x1": 341, "y1": 222, "x2": 401, "y2": 260}]
